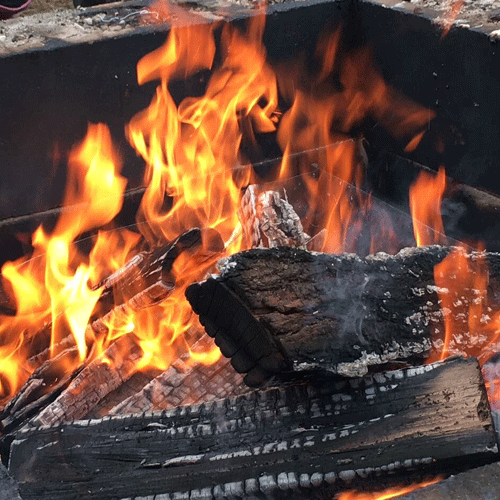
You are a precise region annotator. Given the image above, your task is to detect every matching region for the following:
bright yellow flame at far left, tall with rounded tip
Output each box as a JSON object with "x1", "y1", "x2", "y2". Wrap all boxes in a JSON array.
[{"x1": 0, "y1": 124, "x2": 126, "y2": 402}]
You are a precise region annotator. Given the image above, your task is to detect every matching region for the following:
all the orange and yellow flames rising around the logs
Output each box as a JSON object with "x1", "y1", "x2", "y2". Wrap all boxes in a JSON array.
[{"x1": 0, "y1": 0, "x2": 497, "y2": 450}]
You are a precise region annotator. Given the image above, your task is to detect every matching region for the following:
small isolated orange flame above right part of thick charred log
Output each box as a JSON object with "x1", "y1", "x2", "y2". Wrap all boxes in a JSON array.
[{"x1": 410, "y1": 167, "x2": 446, "y2": 246}]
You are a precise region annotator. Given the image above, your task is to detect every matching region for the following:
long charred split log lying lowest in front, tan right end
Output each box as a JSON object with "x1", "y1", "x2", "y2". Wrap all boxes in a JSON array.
[{"x1": 9, "y1": 359, "x2": 497, "y2": 500}]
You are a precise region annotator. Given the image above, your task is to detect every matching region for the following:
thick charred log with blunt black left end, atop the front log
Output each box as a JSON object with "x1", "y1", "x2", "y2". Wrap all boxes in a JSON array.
[{"x1": 186, "y1": 246, "x2": 500, "y2": 384}]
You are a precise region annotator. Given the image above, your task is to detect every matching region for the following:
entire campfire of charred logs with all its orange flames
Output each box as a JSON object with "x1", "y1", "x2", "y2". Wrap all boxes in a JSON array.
[{"x1": 0, "y1": 0, "x2": 500, "y2": 500}]
